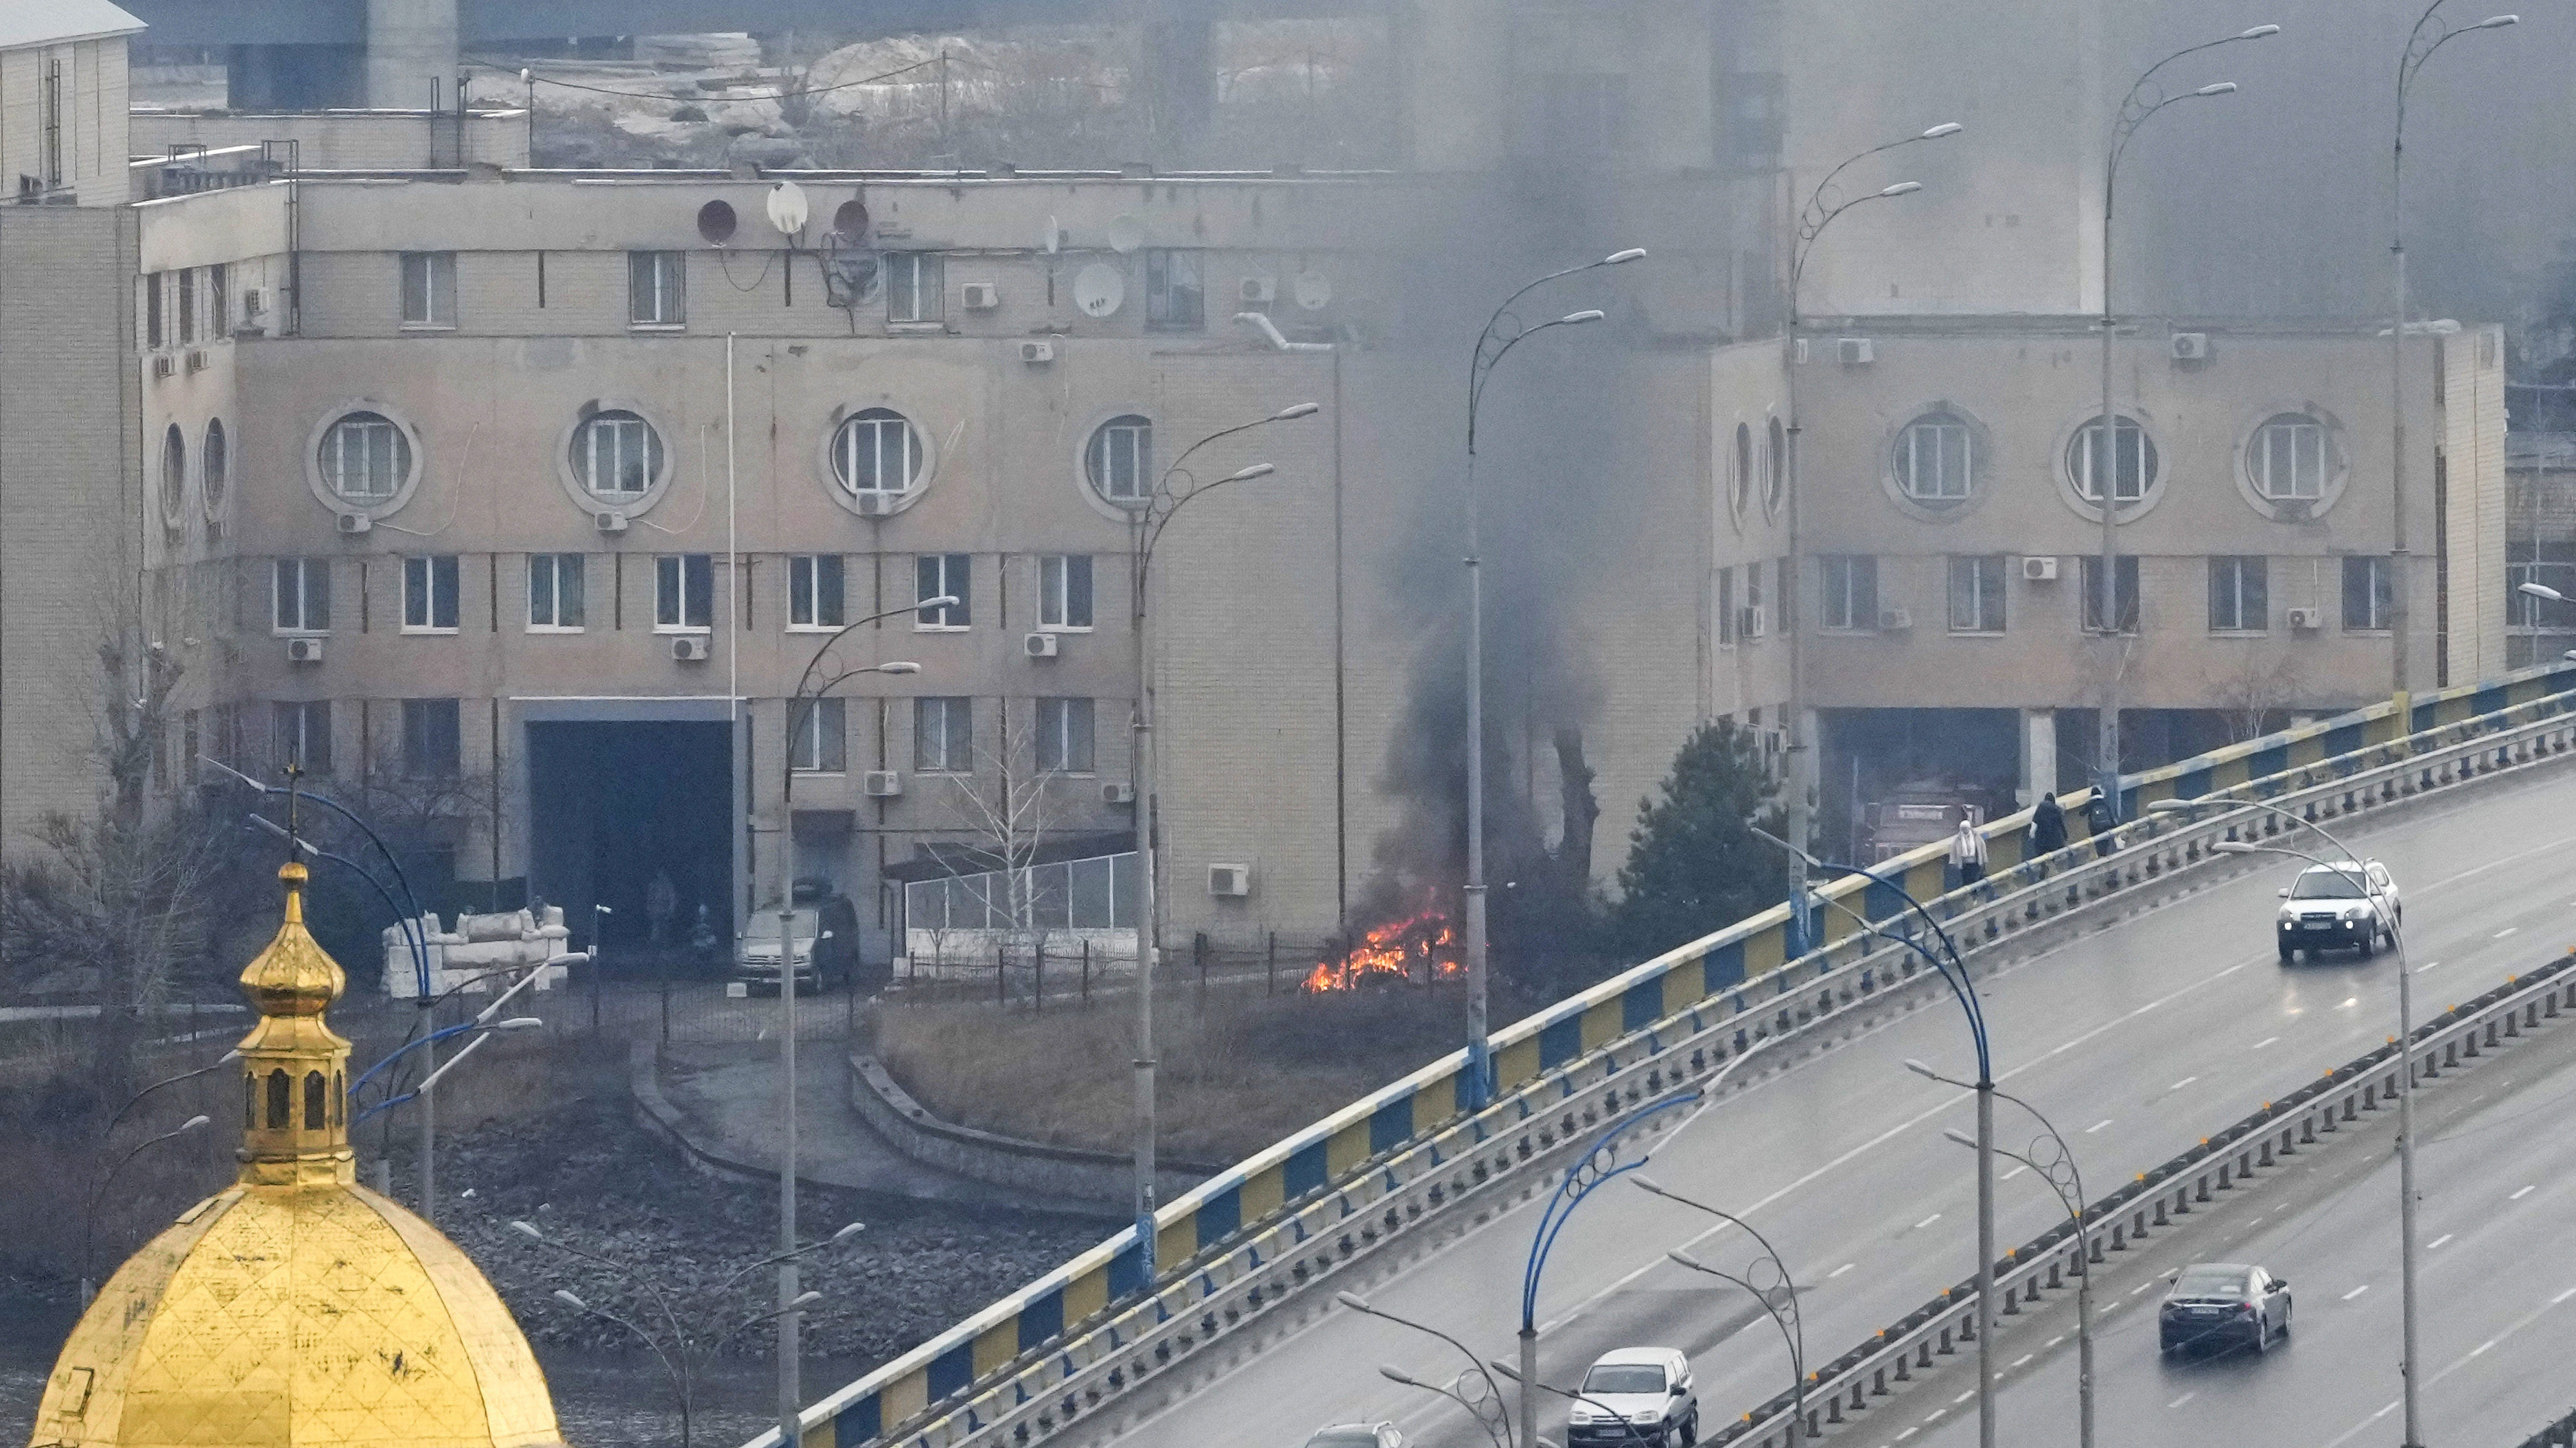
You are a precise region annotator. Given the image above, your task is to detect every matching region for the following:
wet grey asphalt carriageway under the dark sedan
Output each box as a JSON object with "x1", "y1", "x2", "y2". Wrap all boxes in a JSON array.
[{"x1": 1906, "y1": 958, "x2": 2576, "y2": 1448}]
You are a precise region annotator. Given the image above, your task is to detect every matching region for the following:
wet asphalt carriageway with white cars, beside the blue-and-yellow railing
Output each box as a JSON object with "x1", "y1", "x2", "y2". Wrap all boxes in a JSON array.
[{"x1": 1095, "y1": 771, "x2": 2576, "y2": 1448}]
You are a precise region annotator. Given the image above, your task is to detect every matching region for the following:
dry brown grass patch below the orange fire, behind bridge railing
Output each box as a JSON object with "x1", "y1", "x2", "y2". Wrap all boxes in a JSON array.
[{"x1": 873, "y1": 968, "x2": 1522, "y2": 1165}]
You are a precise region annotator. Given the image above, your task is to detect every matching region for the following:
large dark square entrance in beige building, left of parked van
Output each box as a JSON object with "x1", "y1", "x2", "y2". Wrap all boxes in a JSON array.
[{"x1": 528, "y1": 721, "x2": 734, "y2": 946}]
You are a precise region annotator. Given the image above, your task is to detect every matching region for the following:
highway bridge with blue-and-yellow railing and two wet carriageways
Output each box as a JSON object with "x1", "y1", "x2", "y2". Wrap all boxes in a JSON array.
[{"x1": 755, "y1": 667, "x2": 2576, "y2": 1448}]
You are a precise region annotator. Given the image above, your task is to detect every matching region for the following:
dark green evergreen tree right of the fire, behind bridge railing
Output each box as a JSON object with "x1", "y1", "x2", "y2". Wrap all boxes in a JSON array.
[{"x1": 1610, "y1": 719, "x2": 1788, "y2": 964}]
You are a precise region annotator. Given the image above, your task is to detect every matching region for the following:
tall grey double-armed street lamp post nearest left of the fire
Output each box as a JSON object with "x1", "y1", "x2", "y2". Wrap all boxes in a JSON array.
[{"x1": 1128, "y1": 402, "x2": 1324, "y2": 1262}]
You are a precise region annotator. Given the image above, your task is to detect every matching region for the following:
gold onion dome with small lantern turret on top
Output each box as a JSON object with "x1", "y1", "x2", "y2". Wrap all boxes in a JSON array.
[{"x1": 28, "y1": 863, "x2": 561, "y2": 1448}]
